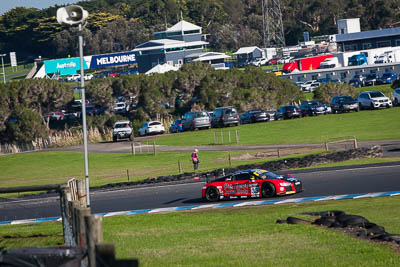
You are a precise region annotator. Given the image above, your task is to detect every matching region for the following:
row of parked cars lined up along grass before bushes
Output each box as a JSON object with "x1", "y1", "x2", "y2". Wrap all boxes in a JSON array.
[{"x1": 113, "y1": 88, "x2": 400, "y2": 141}]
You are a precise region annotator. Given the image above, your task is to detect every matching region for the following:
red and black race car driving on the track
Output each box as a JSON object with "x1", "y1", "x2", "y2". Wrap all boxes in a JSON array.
[{"x1": 201, "y1": 169, "x2": 303, "y2": 201}]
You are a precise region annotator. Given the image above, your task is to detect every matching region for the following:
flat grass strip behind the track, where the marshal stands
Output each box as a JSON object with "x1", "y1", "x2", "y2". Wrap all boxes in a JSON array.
[{"x1": 0, "y1": 151, "x2": 318, "y2": 187}]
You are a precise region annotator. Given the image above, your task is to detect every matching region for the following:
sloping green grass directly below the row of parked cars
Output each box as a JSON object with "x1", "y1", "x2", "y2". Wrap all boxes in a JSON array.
[{"x1": 152, "y1": 108, "x2": 400, "y2": 146}]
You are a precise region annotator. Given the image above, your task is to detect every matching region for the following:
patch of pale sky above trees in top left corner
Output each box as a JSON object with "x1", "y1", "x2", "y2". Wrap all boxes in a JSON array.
[{"x1": 0, "y1": 0, "x2": 82, "y2": 15}]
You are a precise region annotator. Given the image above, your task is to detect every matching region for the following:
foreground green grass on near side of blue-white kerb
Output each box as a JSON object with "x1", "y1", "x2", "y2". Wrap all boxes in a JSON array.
[{"x1": 0, "y1": 197, "x2": 400, "y2": 266}]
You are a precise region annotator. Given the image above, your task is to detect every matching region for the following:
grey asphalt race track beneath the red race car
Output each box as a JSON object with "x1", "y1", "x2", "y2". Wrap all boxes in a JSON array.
[{"x1": 0, "y1": 163, "x2": 400, "y2": 222}]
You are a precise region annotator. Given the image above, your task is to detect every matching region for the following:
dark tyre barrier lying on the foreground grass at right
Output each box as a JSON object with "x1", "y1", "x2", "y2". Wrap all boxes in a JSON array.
[{"x1": 276, "y1": 210, "x2": 400, "y2": 245}]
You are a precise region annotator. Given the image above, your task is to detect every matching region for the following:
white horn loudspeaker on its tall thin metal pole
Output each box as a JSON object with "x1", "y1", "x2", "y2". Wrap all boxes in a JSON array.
[{"x1": 57, "y1": 5, "x2": 90, "y2": 207}]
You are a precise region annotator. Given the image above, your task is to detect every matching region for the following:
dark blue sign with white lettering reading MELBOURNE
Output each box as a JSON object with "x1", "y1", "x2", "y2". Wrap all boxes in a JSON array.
[{"x1": 90, "y1": 52, "x2": 136, "y2": 69}]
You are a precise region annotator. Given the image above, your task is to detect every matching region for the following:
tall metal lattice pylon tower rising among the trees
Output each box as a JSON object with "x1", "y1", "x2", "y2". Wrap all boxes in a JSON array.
[{"x1": 262, "y1": 0, "x2": 285, "y2": 47}]
